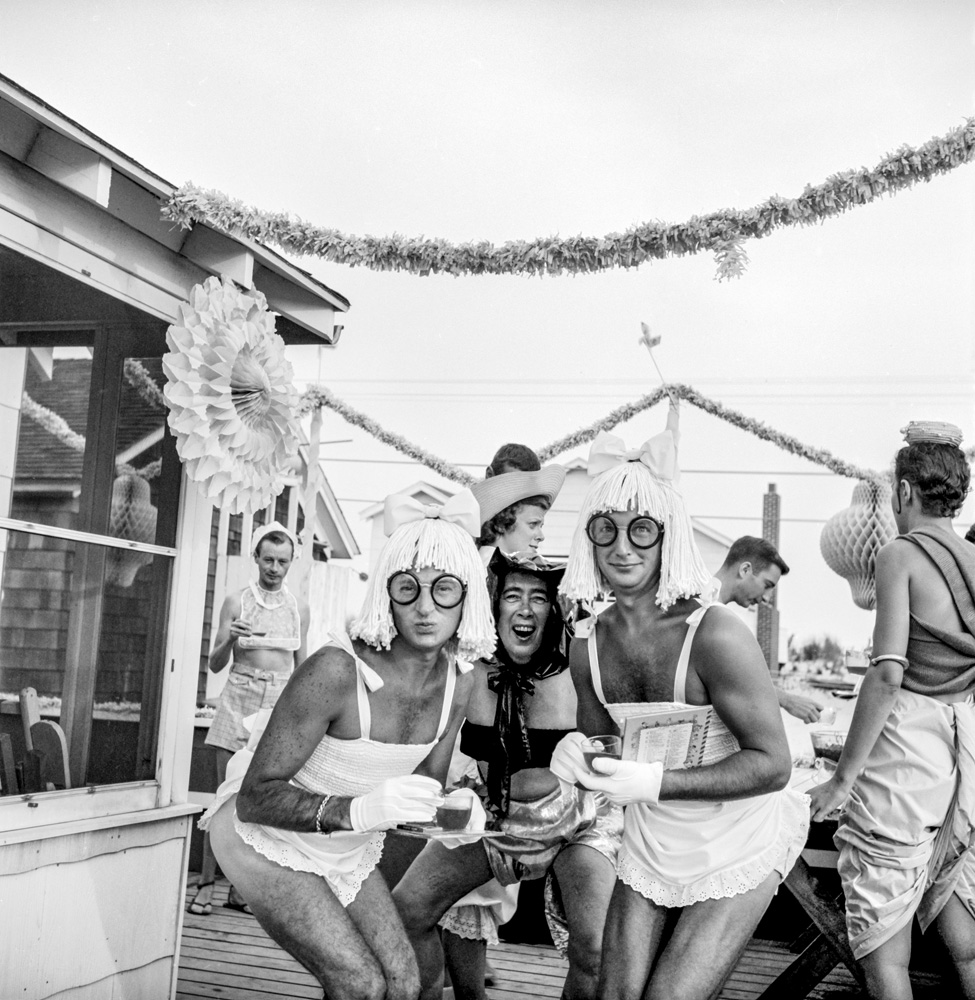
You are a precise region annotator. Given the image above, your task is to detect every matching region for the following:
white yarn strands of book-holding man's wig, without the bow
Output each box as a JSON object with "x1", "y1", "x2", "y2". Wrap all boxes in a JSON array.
[{"x1": 559, "y1": 461, "x2": 712, "y2": 609}]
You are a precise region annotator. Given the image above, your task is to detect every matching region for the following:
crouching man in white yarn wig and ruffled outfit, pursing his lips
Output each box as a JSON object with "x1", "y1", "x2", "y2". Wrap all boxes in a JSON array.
[{"x1": 201, "y1": 490, "x2": 495, "y2": 997}]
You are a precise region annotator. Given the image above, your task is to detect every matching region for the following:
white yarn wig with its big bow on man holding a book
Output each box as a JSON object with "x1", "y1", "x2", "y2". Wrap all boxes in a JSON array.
[{"x1": 560, "y1": 407, "x2": 711, "y2": 609}]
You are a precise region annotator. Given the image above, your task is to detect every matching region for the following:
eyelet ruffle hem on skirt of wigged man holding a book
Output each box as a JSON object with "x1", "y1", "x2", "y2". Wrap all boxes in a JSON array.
[{"x1": 616, "y1": 789, "x2": 809, "y2": 908}]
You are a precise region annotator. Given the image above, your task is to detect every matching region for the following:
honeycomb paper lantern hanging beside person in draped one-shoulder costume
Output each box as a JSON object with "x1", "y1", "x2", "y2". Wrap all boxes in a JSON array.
[{"x1": 819, "y1": 480, "x2": 897, "y2": 611}]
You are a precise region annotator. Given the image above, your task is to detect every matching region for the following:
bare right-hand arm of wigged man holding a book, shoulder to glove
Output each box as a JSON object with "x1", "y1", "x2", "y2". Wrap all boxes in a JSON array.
[{"x1": 660, "y1": 611, "x2": 792, "y2": 801}]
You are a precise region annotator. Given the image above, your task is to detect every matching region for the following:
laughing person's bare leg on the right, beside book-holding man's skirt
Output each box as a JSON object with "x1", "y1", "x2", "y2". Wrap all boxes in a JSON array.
[{"x1": 553, "y1": 844, "x2": 616, "y2": 1000}]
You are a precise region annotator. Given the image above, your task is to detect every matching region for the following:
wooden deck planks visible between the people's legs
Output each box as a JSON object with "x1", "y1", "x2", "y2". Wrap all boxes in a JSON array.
[{"x1": 176, "y1": 882, "x2": 857, "y2": 1000}]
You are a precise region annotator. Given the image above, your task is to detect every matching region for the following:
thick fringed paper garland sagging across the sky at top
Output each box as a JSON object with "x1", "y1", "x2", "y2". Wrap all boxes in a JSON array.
[{"x1": 162, "y1": 118, "x2": 975, "y2": 281}]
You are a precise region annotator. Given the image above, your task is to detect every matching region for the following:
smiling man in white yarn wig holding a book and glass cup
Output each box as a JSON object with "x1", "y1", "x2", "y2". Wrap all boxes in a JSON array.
[{"x1": 551, "y1": 409, "x2": 809, "y2": 998}]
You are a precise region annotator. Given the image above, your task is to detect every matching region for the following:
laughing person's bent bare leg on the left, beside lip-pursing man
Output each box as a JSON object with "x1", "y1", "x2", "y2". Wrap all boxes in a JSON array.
[{"x1": 393, "y1": 841, "x2": 492, "y2": 1000}]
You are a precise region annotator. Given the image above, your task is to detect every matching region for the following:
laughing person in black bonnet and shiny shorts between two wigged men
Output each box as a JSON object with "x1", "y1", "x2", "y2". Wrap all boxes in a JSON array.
[{"x1": 394, "y1": 540, "x2": 622, "y2": 1000}]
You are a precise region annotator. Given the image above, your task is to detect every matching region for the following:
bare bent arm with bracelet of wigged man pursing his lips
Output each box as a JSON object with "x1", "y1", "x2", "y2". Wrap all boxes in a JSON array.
[{"x1": 237, "y1": 647, "x2": 355, "y2": 833}]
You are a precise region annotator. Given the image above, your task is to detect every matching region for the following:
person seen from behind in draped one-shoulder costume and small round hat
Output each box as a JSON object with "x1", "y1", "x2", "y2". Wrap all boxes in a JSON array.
[{"x1": 811, "y1": 421, "x2": 975, "y2": 998}]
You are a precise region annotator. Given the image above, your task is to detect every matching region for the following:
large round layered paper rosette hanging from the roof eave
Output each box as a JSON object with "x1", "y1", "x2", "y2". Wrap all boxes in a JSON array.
[{"x1": 163, "y1": 277, "x2": 298, "y2": 514}]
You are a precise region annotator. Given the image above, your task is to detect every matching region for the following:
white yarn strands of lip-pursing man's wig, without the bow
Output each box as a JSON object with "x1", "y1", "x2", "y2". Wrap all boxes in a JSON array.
[{"x1": 349, "y1": 517, "x2": 497, "y2": 660}]
